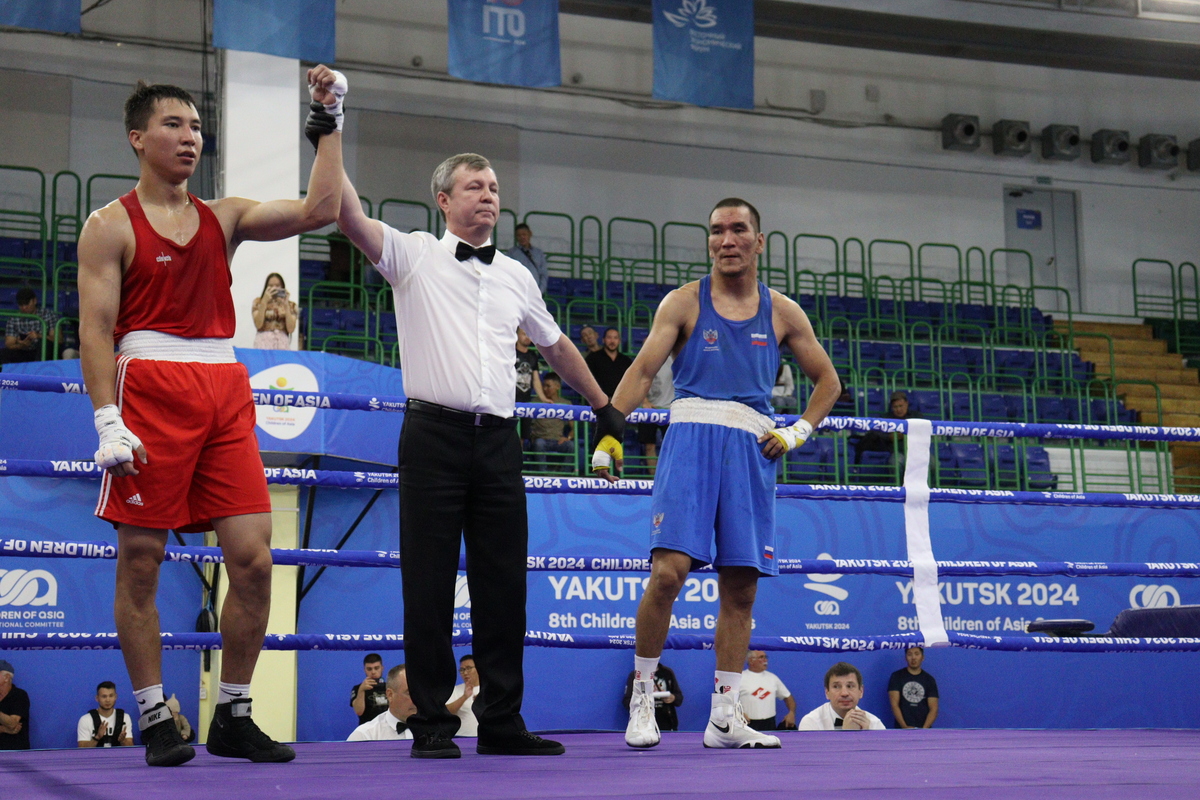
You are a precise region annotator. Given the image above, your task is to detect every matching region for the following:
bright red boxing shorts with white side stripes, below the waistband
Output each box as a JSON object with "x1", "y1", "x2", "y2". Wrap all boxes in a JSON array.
[{"x1": 96, "y1": 356, "x2": 271, "y2": 533}]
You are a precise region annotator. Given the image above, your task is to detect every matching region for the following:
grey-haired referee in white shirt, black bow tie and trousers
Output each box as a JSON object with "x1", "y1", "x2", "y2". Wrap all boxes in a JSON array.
[{"x1": 337, "y1": 154, "x2": 624, "y2": 758}]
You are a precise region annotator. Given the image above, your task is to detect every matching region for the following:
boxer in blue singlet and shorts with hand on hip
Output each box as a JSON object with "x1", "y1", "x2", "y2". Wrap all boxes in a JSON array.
[{"x1": 593, "y1": 198, "x2": 841, "y2": 748}]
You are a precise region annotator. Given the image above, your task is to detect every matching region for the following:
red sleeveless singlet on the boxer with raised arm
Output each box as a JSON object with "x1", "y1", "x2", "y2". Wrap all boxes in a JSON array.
[{"x1": 113, "y1": 191, "x2": 236, "y2": 342}]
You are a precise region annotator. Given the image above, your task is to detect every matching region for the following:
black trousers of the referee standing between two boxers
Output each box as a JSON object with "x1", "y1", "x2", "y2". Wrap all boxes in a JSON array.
[{"x1": 400, "y1": 411, "x2": 529, "y2": 736}]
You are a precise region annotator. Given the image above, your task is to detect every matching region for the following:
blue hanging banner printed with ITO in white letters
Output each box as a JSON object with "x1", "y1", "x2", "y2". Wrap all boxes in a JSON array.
[{"x1": 449, "y1": 0, "x2": 563, "y2": 86}]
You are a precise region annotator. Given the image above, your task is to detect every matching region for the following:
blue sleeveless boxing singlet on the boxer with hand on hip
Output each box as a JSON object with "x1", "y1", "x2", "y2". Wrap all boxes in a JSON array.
[{"x1": 671, "y1": 275, "x2": 779, "y2": 415}]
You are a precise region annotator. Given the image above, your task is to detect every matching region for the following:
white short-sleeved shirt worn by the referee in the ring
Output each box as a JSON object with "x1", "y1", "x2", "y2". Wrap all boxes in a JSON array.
[{"x1": 374, "y1": 223, "x2": 563, "y2": 417}]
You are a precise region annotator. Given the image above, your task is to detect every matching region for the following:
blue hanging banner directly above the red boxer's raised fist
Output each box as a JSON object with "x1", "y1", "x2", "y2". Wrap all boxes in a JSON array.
[{"x1": 212, "y1": 0, "x2": 337, "y2": 64}]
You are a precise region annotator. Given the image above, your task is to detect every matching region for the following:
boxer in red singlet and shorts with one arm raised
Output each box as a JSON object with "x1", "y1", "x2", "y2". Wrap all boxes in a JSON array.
[{"x1": 79, "y1": 66, "x2": 346, "y2": 766}]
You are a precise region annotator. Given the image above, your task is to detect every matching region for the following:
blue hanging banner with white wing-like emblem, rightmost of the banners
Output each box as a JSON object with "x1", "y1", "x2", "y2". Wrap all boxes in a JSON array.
[{"x1": 654, "y1": 0, "x2": 754, "y2": 108}]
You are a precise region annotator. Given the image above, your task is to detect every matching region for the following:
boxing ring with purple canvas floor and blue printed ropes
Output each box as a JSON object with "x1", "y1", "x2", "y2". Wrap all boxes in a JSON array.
[{"x1": 0, "y1": 373, "x2": 1200, "y2": 798}]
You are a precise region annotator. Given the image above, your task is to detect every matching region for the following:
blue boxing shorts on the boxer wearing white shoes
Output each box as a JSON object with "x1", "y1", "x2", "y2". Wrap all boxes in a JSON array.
[{"x1": 650, "y1": 407, "x2": 779, "y2": 576}]
